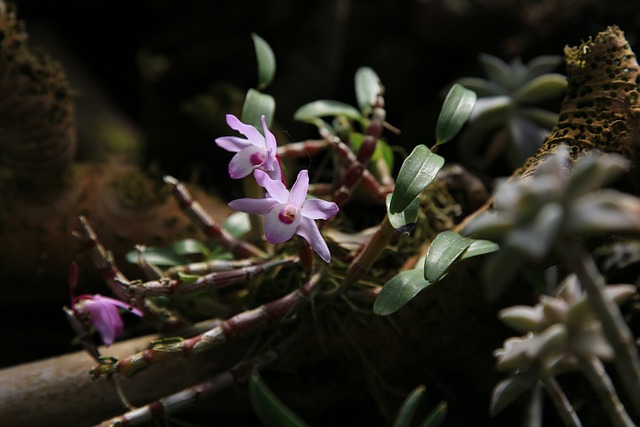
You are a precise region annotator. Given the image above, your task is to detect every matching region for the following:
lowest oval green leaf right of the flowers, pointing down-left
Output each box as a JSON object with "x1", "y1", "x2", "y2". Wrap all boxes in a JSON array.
[{"x1": 373, "y1": 269, "x2": 431, "y2": 316}]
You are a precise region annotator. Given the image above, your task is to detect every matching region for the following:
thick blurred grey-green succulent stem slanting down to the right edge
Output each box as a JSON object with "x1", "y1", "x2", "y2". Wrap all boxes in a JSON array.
[{"x1": 560, "y1": 241, "x2": 640, "y2": 417}]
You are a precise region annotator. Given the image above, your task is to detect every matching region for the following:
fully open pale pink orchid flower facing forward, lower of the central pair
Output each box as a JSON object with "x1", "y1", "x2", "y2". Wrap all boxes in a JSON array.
[{"x1": 229, "y1": 170, "x2": 339, "y2": 262}]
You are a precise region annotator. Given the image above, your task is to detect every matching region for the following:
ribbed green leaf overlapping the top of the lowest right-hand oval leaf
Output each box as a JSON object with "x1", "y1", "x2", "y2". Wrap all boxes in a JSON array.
[{"x1": 424, "y1": 231, "x2": 473, "y2": 283}]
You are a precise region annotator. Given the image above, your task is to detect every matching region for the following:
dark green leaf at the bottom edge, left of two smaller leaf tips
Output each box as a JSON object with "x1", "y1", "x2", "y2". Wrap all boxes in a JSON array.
[{"x1": 249, "y1": 373, "x2": 307, "y2": 427}]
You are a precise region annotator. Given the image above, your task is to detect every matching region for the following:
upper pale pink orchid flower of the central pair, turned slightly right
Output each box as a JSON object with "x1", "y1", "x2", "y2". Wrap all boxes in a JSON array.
[{"x1": 216, "y1": 114, "x2": 282, "y2": 180}]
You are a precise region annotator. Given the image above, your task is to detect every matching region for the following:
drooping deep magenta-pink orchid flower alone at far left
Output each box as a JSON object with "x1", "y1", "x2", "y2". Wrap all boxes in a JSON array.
[{"x1": 73, "y1": 294, "x2": 142, "y2": 347}]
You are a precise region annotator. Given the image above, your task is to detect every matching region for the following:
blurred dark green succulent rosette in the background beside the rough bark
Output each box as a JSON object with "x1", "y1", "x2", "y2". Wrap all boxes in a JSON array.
[{"x1": 456, "y1": 53, "x2": 567, "y2": 171}]
